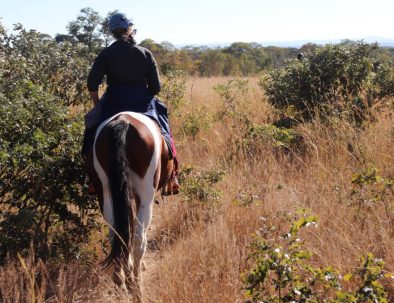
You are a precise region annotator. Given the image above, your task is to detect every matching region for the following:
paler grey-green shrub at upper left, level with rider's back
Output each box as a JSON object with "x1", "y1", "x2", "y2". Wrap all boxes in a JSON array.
[{"x1": 0, "y1": 24, "x2": 90, "y2": 105}]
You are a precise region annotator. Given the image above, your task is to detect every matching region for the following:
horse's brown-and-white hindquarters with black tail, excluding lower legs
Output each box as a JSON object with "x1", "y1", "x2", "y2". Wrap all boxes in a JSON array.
[{"x1": 90, "y1": 112, "x2": 172, "y2": 265}]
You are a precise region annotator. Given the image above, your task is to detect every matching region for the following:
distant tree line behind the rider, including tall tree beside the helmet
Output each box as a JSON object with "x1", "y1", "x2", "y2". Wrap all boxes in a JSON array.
[{"x1": 50, "y1": 8, "x2": 394, "y2": 77}]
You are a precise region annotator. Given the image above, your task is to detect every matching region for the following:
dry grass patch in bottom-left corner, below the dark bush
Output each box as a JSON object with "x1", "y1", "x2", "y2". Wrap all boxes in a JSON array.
[{"x1": 0, "y1": 253, "x2": 130, "y2": 303}]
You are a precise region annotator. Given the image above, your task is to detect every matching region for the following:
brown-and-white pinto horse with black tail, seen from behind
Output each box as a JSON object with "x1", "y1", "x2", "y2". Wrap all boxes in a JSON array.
[{"x1": 88, "y1": 112, "x2": 174, "y2": 302}]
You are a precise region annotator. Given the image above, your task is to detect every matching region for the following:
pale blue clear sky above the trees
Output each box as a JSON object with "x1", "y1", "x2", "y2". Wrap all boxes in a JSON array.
[{"x1": 0, "y1": 0, "x2": 394, "y2": 44}]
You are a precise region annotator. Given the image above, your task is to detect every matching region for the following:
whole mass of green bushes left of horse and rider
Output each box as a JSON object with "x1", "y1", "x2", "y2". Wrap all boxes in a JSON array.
[{"x1": 0, "y1": 24, "x2": 103, "y2": 264}]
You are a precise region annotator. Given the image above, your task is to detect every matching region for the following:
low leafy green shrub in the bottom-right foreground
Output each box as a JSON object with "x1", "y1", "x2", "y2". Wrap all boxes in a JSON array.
[{"x1": 244, "y1": 216, "x2": 392, "y2": 303}]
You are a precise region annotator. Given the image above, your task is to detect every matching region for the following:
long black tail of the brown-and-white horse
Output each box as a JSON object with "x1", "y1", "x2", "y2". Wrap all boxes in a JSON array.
[{"x1": 103, "y1": 121, "x2": 134, "y2": 267}]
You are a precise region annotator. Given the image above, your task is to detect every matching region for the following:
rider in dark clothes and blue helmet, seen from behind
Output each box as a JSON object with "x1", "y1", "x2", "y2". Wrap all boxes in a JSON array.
[{"x1": 82, "y1": 13, "x2": 179, "y2": 193}]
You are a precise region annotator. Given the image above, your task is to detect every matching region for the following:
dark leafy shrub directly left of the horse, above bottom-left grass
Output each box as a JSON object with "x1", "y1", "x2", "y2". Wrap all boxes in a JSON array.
[{"x1": 0, "y1": 80, "x2": 97, "y2": 263}]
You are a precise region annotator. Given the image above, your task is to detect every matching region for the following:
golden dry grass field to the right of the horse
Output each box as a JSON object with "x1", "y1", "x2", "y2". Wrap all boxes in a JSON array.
[{"x1": 146, "y1": 78, "x2": 394, "y2": 302}]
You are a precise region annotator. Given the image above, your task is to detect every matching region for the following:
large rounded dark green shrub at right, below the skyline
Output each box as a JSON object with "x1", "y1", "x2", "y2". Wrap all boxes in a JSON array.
[{"x1": 260, "y1": 43, "x2": 392, "y2": 122}]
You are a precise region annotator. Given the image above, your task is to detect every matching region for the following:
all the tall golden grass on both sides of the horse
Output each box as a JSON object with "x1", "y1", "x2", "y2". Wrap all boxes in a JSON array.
[{"x1": 0, "y1": 78, "x2": 394, "y2": 303}]
